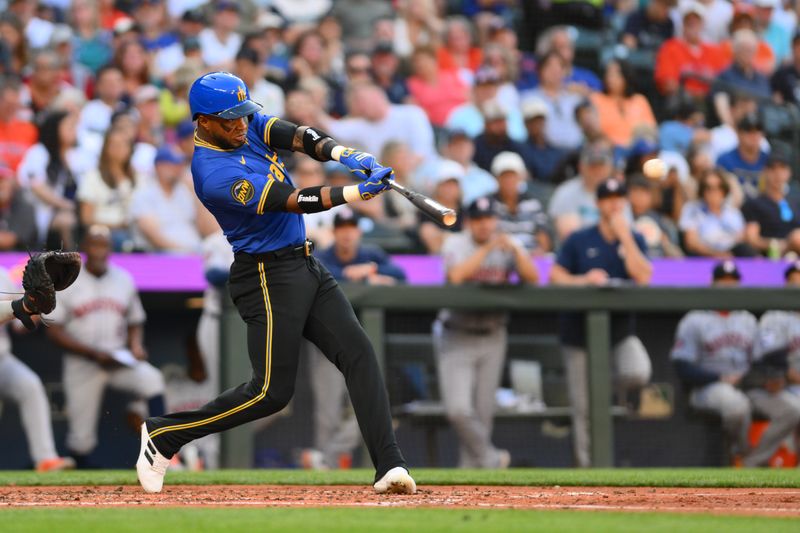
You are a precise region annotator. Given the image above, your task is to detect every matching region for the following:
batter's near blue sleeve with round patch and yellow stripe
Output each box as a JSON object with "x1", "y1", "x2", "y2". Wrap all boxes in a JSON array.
[{"x1": 202, "y1": 165, "x2": 294, "y2": 215}]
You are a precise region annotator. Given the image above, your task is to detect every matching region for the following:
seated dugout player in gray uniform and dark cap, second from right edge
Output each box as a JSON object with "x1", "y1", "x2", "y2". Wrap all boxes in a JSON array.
[{"x1": 670, "y1": 260, "x2": 800, "y2": 467}]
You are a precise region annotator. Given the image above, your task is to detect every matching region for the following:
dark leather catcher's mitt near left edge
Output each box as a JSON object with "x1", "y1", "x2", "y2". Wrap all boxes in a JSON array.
[{"x1": 22, "y1": 252, "x2": 81, "y2": 314}]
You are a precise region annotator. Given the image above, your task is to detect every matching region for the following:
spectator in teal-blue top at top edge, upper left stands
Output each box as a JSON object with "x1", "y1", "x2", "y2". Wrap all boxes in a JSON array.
[{"x1": 70, "y1": 0, "x2": 111, "y2": 73}]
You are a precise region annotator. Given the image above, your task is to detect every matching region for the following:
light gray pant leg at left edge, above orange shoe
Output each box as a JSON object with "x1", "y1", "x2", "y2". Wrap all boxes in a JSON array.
[{"x1": 0, "y1": 353, "x2": 58, "y2": 463}]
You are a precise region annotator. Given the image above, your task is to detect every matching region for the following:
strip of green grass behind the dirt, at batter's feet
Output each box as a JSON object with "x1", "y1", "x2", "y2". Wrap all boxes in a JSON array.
[{"x1": 0, "y1": 468, "x2": 800, "y2": 488}]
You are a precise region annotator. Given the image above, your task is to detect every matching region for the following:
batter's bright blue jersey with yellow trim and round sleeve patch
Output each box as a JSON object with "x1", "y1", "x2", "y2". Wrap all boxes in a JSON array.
[{"x1": 192, "y1": 114, "x2": 306, "y2": 254}]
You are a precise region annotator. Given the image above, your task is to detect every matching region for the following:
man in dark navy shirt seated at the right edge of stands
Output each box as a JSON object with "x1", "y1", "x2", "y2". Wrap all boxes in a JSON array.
[{"x1": 742, "y1": 147, "x2": 800, "y2": 258}]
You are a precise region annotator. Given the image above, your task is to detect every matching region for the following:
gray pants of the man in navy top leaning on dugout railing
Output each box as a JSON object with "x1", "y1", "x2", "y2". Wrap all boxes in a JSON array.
[{"x1": 562, "y1": 335, "x2": 652, "y2": 467}]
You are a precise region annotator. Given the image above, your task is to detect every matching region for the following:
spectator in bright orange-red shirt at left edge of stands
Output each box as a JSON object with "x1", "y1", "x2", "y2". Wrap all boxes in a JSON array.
[{"x1": 0, "y1": 75, "x2": 39, "y2": 171}]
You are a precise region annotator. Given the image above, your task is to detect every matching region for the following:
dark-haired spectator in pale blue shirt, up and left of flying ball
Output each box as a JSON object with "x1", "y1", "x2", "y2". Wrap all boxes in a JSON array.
[{"x1": 526, "y1": 52, "x2": 583, "y2": 150}]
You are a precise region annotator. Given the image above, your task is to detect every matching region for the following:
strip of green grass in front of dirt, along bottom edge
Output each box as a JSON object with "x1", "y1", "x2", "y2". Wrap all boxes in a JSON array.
[{"x1": 0, "y1": 508, "x2": 798, "y2": 533}]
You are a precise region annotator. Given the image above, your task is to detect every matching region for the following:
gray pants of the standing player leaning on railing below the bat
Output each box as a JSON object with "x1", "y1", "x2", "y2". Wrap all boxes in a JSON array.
[{"x1": 433, "y1": 321, "x2": 508, "y2": 468}]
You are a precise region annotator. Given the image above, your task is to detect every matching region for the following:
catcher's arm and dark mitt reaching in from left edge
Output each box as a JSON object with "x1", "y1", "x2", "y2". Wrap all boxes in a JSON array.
[{"x1": 6, "y1": 251, "x2": 81, "y2": 329}]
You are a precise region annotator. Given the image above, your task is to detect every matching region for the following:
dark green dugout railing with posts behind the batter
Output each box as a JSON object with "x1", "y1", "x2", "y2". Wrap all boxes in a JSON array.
[{"x1": 221, "y1": 285, "x2": 800, "y2": 468}]
